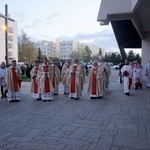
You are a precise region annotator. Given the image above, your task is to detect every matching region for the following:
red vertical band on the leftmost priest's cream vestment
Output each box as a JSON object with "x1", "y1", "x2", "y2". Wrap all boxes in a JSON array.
[{"x1": 12, "y1": 68, "x2": 19, "y2": 92}]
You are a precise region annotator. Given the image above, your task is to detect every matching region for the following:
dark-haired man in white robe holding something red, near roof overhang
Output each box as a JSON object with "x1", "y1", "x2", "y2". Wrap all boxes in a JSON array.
[{"x1": 121, "y1": 60, "x2": 132, "y2": 96}]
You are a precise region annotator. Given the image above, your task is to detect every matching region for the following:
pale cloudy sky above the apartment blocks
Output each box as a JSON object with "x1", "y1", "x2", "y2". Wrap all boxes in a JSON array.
[{"x1": 0, "y1": 0, "x2": 118, "y2": 51}]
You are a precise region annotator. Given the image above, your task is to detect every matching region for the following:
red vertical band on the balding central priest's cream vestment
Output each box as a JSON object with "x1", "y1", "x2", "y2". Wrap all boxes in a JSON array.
[{"x1": 70, "y1": 66, "x2": 77, "y2": 93}]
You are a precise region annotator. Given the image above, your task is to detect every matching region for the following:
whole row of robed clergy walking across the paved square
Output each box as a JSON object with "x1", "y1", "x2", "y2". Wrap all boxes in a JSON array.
[{"x1": 0, "y1": 57, "x2": 150, "y2": 102}]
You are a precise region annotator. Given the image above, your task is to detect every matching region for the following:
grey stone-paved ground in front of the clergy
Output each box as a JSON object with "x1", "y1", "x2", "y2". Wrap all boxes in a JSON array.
[{"x1": 0, "y1": 70, "x2": 150, "y2": 150}]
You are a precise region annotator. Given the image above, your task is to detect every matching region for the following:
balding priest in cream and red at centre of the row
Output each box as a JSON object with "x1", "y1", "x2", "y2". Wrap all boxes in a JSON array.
[{"x1": 69, "y1": 58, "x2": 85, "y2": 100}]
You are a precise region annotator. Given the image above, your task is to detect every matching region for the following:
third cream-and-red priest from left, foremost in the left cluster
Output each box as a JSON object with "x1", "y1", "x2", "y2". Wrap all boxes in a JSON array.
[{"x1": 36, "y1": 58, "x2": 54, "y2": 101}]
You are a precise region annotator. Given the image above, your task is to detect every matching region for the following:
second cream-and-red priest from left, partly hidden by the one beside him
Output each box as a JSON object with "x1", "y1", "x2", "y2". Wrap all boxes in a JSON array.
[{"x1": 30, "y1": 60, "x2": 41, "y2": 100}]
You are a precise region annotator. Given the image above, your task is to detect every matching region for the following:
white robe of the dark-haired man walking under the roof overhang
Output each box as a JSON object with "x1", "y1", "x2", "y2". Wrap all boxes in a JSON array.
[{"x1": 121, "y1": 65, "x2": 133, "y2": 93}]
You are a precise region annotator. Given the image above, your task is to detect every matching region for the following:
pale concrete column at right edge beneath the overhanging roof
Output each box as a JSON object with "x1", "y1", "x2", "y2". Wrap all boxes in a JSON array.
[{"x1": 142, "y1": 32, "x2": 150, "y2": 81}]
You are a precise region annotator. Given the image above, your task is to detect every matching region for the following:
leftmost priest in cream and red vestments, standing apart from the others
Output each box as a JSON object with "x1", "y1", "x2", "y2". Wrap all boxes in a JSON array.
[{"x1": 5, "y1": 60, "x2": 22, "y2": 102}]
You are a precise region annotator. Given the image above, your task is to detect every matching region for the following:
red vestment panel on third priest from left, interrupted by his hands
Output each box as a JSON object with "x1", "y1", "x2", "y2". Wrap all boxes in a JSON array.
[{"x1": 43, "y1": 66, "x2": 50, "y2": 93}]
